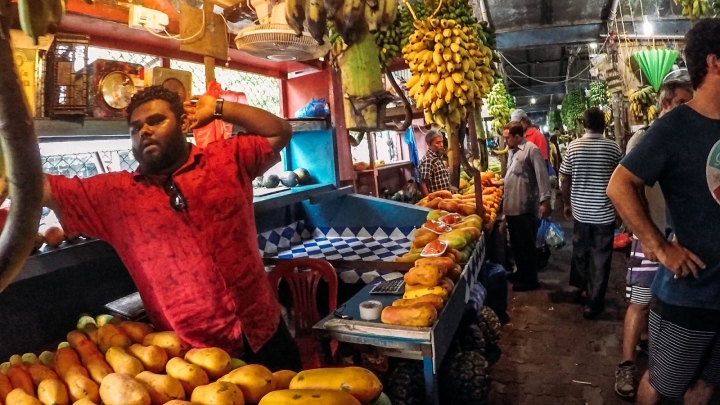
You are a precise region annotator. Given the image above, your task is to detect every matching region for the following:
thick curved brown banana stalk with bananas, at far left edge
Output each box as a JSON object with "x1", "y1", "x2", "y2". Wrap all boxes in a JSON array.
[{"x1": 0, "y1": 0, "x2": 65, "y2": 291}]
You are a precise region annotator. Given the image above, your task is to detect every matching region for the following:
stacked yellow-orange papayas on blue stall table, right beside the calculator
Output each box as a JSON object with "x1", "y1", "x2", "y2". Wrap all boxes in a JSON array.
[{"x1": 380, "y1": 257, "x2": 462, "y2": 327}]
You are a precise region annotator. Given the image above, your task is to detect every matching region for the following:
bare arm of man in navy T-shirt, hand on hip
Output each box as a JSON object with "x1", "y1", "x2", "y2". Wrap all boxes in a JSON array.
[{"x1": 607, "y1": 165, "x2": 705, "y2": 277}]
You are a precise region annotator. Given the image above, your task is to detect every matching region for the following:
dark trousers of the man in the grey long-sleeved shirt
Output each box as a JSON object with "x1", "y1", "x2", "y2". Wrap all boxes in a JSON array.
[{"x1": 505, "y1": 214, "x2": 538, "y2": 285}]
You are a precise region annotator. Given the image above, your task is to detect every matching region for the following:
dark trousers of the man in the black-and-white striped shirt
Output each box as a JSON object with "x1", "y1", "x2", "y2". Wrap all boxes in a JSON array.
[{"x1": 570, "y1": 220, "x2": 615, "y2": 311}]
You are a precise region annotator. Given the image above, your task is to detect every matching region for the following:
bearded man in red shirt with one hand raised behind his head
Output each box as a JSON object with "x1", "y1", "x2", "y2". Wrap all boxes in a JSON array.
[{"x1": 44, "y1": 86, "x2": 300, "y2": 370}]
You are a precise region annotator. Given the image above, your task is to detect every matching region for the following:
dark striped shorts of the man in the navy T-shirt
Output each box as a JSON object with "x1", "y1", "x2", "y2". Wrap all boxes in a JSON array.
[{"x1": 648, "y1": 297, "x2": 720, "y2": 398}]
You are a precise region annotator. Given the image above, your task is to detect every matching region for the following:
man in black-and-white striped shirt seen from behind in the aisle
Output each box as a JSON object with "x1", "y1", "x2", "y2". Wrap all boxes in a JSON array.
[{"x1": 560, "y1": 107, "x2": 622, "y2": 319}]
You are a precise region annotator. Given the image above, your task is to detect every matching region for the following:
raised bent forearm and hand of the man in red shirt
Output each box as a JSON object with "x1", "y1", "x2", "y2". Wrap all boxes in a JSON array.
[{"x1": 184, "y1": 96, "x2": 292, "y2": 153}]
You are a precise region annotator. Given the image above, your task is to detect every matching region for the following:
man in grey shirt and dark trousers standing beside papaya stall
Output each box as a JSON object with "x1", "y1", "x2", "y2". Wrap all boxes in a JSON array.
[{"x1": 503, "y1": 121, "x2": 551, "y2": 291}]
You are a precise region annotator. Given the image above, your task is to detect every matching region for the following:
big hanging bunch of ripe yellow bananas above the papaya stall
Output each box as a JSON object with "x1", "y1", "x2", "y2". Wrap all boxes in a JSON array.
[{"x1": 402, "y1": 18, "x2": 494, "y2": 128}]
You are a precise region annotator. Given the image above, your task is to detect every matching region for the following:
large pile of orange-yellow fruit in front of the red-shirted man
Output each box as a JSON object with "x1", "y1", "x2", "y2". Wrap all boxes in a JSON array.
[{"x1": 0, "y1": 315, "x2": 388, "y2": 405}]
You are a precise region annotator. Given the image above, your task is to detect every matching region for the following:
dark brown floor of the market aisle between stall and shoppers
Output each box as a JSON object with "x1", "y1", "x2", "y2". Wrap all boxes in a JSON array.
[{"x1": 489, "y1": 218, "x2": 720, "y2": 405}]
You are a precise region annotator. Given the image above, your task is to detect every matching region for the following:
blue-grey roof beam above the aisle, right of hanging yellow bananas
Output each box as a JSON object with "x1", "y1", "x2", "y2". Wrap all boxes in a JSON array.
[{"x1": 497, "y1": 23, "x2": 603, "y2": 50}]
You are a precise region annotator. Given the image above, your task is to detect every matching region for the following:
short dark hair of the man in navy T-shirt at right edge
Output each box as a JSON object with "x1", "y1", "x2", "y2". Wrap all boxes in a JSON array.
[{"x1": 685, "y1": 18, "x2": 720, "y2": 89}]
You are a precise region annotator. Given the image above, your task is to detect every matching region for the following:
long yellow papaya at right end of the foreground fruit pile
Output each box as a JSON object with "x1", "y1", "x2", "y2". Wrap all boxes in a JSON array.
[{"x1": 290, "y1": 366, "x2": 382, "y2": 404}]
